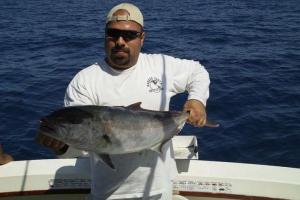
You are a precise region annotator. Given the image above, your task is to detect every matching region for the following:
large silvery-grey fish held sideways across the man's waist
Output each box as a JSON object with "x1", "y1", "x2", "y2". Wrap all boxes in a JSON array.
[{"x1": 38, "y1": 102, "x2": 218, "y2": 168}]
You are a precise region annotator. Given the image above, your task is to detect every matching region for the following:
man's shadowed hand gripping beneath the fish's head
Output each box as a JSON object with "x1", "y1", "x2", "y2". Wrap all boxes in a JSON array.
[{"x1": 36, "y1": 133, "x2": 69, "y2": 155}]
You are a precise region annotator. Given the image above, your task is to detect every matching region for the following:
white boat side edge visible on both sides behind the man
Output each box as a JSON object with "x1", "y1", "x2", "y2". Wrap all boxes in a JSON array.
[{"x1": 0, "y1": 158, "x2": 300, "y2": 200}]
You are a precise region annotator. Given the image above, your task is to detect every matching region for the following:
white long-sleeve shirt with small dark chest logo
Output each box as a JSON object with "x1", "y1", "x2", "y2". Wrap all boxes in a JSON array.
[{"x1": 64, "y1": 53, "x2": 210, "y2": 200}]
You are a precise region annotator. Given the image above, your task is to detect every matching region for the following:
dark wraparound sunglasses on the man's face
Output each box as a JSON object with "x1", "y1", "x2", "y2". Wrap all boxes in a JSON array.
[{"x1": 105, "y1": 28, "x2": 142, "y2": 42}]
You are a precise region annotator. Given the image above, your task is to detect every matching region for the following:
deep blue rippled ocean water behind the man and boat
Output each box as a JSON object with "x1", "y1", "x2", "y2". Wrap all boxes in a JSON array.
[{"x1": 0, "y1": 0, "x2": 300, "y2": 168}]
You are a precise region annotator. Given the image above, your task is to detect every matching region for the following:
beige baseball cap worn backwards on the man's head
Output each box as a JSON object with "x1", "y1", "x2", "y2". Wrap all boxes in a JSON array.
[{"x1": 106, "y1": 3, "x2": 144, "y2": 27}]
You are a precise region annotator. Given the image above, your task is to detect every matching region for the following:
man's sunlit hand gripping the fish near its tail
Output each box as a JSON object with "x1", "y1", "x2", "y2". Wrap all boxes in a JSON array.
[{"x1": 183, "y1": 99, "x2": 206, "y2": 127}]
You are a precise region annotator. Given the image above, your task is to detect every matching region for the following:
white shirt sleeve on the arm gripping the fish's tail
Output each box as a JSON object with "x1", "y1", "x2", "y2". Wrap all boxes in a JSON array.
[{"x1": 166, "y1": 54, "x2": 210, "y2": 105}]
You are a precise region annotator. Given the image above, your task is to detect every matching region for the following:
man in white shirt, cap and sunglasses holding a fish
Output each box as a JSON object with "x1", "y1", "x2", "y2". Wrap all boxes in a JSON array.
[{"x1": 39, "y1": 3, "x2": 210, "y2": 200}]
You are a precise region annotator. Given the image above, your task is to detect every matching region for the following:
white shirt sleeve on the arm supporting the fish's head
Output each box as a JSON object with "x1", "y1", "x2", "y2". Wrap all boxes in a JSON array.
[{"x1": 64, "y1": 71, "x2": 93, "y2": 107}]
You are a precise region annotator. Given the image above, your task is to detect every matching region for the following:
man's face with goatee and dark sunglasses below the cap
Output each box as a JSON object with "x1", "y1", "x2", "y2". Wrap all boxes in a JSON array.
[{"x1": 105, "y1": 13, "x2": 144, "y2": 70}]
